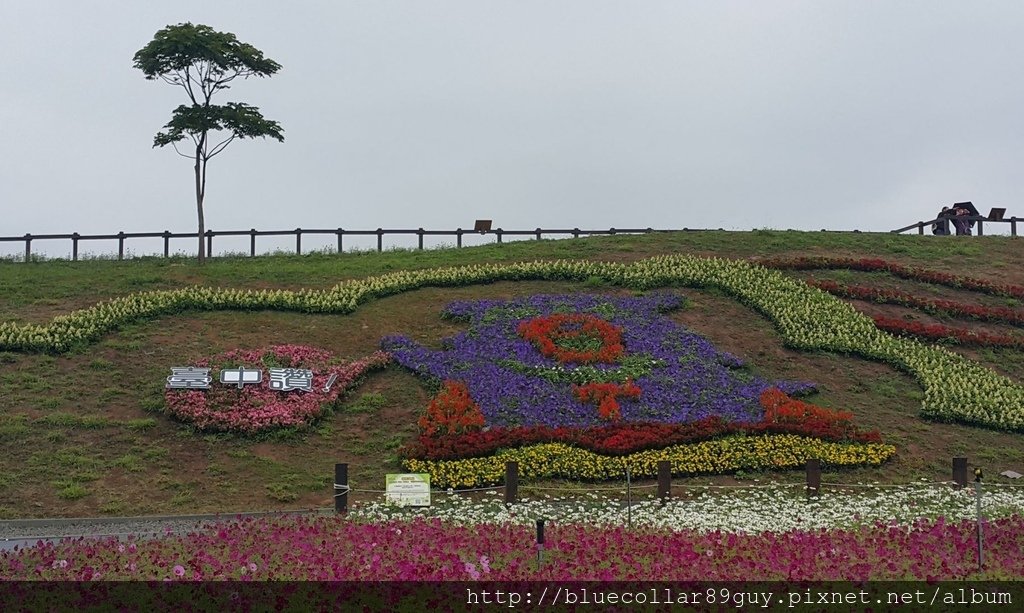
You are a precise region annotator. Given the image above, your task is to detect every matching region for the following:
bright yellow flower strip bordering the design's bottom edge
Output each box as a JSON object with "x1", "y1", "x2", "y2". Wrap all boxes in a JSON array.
[{"x1": 403, "y1": 434, "x2": 896, "y2": 488}]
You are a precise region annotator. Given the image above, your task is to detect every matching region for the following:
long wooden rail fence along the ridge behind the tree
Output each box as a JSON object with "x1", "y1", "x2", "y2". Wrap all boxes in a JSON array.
[{"x1": 0, "y1": 228, "x2": 692, "y2": 262}]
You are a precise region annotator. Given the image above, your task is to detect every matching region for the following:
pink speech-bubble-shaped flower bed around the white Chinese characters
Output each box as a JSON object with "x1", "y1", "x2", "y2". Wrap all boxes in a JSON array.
[{"x1": 164, "y1": 345, "x2": 391, "y2": 434}]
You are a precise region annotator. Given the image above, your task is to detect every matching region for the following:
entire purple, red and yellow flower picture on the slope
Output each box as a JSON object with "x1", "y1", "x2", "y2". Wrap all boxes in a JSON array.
[{"x1": 381, "y1": 293, "x2": 894, "y2": 486}]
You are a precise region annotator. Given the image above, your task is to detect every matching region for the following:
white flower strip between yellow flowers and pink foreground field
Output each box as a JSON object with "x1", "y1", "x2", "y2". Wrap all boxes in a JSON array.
[{"x1": 348, "y1": 484, "x2": 1024, "y2": 533}]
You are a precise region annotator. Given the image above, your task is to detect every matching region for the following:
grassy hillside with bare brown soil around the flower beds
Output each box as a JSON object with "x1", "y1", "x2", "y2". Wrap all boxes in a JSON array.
[{"x1": 0, "y1": 231, "x2": 1024, "y2": 518}]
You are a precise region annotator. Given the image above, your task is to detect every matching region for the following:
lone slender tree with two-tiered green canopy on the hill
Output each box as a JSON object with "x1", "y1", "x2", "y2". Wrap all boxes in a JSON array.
[{"x1": 134, "y1": 24, "x2": 285, "y2": 263}]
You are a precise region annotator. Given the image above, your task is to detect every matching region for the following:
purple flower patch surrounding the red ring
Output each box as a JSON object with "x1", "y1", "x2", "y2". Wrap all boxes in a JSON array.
[{"x1": 381, "y1": 293, "x2": 814, "y2": 428}]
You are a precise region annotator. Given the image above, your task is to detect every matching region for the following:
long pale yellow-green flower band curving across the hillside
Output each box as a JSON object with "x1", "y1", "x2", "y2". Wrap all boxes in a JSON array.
[{"x1": 0, "y1": 255, "x2": 1024, "y2": 431}]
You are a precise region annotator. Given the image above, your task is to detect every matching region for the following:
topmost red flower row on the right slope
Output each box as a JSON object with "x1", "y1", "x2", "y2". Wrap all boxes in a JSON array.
[{"x1": 756, "y1": 256, "x2": 1024, "y2": 299}]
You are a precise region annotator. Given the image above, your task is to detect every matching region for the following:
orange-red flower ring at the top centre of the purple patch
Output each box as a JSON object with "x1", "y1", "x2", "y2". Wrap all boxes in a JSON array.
[{"x1": 517, "y1": 313, "x2": 624, "y2": 363}]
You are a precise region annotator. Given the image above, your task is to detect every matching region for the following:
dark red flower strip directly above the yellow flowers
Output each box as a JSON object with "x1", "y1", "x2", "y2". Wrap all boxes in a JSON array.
[{"x1": 401, "y1": 390, "x2": 882, "y2": 459}]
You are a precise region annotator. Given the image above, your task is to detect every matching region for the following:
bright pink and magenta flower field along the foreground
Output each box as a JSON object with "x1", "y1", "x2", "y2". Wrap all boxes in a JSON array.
[{"x1": 0, "y1": 517, "x2": 1024, "y2": 581}]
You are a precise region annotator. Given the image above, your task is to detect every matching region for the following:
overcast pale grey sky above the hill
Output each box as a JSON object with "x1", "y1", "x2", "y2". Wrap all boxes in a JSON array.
[{"x1": 0, "y1": 0, "x2": 1024, "y2": 253}]
